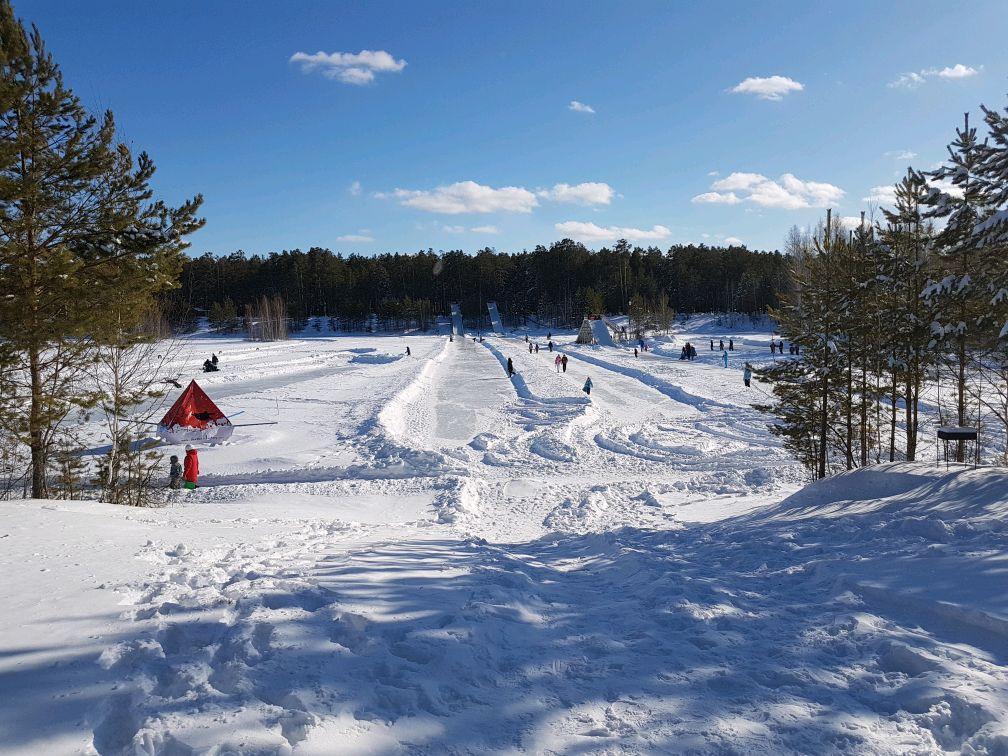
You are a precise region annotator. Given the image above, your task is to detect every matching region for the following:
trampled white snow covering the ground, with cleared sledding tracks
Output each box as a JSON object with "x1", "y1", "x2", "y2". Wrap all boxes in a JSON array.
[{"x1": 0, "y1": 319, "x2": 1008, "y2": 754}]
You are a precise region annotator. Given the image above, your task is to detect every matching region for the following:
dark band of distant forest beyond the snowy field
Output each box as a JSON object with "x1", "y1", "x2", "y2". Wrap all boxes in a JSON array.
[{"x1": 165, "y1": 239, "x2": 789, "y2": 330}]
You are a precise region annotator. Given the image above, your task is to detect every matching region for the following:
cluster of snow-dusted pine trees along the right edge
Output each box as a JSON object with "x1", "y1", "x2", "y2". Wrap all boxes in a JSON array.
[{"x1": 761, "y1": 108, "x2": 1008, "y2": 478}]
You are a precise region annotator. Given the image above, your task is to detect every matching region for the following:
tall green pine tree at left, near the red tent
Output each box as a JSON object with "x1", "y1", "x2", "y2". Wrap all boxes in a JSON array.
[{"x1": 0, "y1": 7, "x2": 202, "y2": 504}]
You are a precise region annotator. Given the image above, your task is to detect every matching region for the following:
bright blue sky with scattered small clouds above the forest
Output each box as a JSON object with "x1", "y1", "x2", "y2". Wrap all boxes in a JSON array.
[{"x1": 15, "y1": 0, "x2": 1008, "y2": 254}]
